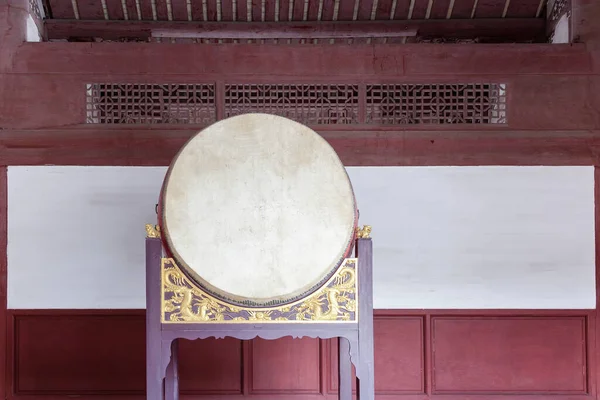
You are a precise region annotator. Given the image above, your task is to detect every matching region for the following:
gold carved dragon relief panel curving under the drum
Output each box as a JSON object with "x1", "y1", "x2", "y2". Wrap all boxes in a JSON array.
[{"x1": 162, "y1": 258, "x2": 357, "y2": 323}]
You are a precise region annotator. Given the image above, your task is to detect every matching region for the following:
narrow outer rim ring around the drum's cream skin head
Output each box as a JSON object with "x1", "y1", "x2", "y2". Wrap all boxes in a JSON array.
[{"x1": 157, "y1": 113, "x2": 358, "y2": 309}]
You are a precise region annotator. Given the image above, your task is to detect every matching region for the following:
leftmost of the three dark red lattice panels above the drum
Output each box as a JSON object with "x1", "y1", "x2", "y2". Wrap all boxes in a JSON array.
[{"x1": 87, "y1": 83, "x2": 217, "y2": 125}]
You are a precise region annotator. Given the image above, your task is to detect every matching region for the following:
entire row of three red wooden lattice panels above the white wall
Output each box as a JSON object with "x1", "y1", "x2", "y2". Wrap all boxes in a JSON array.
[{"x1": 87, "y1": 83, "x2": 507, "y2": 126}]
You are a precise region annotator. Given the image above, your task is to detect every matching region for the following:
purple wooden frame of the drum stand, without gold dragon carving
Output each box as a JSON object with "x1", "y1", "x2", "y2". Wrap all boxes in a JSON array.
[{"x1": 146, "y1": 237, "x2": 375, "y2": 400}]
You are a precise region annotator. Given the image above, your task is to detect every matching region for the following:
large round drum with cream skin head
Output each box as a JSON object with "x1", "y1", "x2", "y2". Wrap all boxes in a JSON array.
[{"x1": 158, "y1": 114, "x2": 358, "y2": 307}]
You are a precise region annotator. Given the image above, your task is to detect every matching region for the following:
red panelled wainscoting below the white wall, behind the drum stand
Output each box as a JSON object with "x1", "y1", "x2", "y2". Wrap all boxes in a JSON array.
[{"x1": 8, "y1": 310, "x2": 596, "y2": 400}]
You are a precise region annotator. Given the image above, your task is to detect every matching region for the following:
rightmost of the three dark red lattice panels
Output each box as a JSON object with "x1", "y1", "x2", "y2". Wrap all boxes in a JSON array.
[{"x1": 366, "y1": 83, "x2": 506, "y2": 125}]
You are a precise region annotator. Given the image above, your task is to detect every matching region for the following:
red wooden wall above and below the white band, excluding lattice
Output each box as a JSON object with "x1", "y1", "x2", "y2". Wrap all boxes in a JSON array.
[{"x1": 0, "y1": 2, "x2": 600, "y2": 400}]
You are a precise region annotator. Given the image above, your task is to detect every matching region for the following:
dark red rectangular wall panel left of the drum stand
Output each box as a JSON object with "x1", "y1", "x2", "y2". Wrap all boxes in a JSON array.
[{"x1": 13, "y1": 314, "x2": 146, "y2": 395}]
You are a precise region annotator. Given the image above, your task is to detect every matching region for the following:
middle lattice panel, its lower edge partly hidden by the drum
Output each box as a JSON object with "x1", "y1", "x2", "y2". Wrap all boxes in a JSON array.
[{"x1": 224, "y1": 84, "x2": 359, "y2": 125}]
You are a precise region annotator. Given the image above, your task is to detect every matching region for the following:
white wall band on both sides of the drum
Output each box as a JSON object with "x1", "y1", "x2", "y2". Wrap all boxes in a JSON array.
[{"x1": 8, "y1": 166, "x2": 595, "y2": 309}]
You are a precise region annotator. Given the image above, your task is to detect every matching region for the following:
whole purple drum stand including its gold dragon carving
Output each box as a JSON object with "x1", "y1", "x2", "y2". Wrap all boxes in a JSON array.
[{"x1": 146, "y1": 225, "x2": 375, "y2": 400}]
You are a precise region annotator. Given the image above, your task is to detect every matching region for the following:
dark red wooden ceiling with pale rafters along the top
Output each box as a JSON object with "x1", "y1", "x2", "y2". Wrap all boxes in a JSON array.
[{"x1": 42, "y1": 0, "x2": 552, "y2": 43}]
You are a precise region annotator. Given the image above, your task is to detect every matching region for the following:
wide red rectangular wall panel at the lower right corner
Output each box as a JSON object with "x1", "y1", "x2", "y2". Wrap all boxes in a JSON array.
[{"x1": 432, "y1": 317, "x2": 587, "y2": 393}]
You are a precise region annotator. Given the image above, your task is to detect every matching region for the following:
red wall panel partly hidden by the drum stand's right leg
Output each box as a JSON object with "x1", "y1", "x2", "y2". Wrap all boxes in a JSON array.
[{"x1": 329, "y1": 316, "x2": 425, "y2": 394}]
